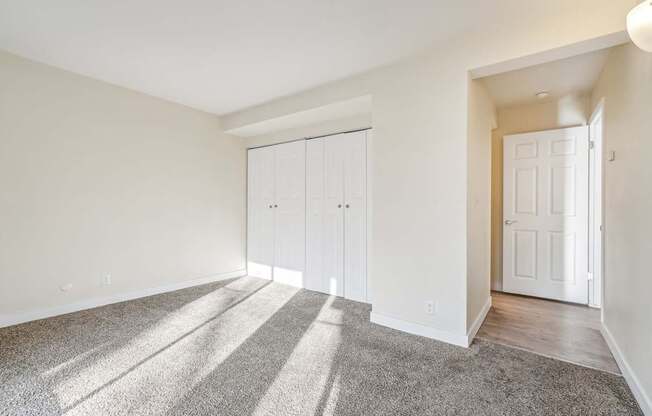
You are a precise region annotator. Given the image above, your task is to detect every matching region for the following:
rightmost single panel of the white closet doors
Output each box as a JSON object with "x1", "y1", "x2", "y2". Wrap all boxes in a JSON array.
[{"x1": 342, "y1": 131, "x2": 367, "y2": 302}]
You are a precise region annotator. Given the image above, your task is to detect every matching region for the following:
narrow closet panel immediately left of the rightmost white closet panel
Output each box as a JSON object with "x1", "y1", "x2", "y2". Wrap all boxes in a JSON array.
[{"x1": 322, "y1": 135, "x2": 344, "y2": 296}]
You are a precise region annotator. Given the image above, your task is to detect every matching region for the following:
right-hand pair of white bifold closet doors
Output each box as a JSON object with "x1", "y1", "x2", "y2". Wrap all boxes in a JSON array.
[{"x1": 306, "y1": 132, "x2": 367, "y2": 301}]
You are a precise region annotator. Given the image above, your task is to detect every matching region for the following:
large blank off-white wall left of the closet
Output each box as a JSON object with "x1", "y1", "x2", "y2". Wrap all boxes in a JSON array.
[{"x1": 0, "y1": 52, "x2": 245, "y2": 322}]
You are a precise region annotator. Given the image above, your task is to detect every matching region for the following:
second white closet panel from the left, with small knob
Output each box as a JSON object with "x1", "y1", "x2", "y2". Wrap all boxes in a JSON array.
[{"x1": 272, "y1": 140, "x2": 306, "y2": 287}]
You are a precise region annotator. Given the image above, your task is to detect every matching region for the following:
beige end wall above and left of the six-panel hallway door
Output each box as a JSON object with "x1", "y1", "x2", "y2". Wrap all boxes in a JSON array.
[{"x1": 491, "y1": 95, "x2": 590, "y2": 290}]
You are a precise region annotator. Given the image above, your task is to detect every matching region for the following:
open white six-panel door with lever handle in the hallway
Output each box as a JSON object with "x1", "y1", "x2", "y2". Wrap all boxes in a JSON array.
[{"x1": 503, "y1": 127, "x2": 588, "y2": 304}]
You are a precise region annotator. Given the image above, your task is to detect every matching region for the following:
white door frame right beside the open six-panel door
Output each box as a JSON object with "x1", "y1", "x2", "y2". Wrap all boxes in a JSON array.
[{"x1": 588, "y1": 98, "x2": 605, "y2": 308}]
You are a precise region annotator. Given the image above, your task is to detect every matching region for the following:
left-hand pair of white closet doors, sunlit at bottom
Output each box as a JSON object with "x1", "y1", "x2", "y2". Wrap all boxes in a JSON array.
[{"x1": 247, "y1": 141, "x2": 306, "y2": 287}]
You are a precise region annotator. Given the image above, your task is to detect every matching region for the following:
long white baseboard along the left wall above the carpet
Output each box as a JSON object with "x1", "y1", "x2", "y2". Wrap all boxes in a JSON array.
[{"x1": 0, "y1": 269, "x2": 247, "y2": 328}]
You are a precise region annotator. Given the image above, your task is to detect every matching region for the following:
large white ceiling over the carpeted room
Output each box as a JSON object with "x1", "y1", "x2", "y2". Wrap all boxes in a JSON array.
[{"x1": 0, "y1": 0, "x2": 510, "y2": 115}]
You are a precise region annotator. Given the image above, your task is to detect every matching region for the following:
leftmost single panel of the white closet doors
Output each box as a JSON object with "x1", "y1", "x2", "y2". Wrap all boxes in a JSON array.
[{"x1": 247, "y1": 147, "x2": 274, "y2": 279}]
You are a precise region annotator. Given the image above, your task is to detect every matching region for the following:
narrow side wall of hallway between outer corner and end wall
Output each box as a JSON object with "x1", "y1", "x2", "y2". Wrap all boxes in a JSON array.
[{"x1": 466, "y1": 80, "x2": 497, "y2": 329}]
